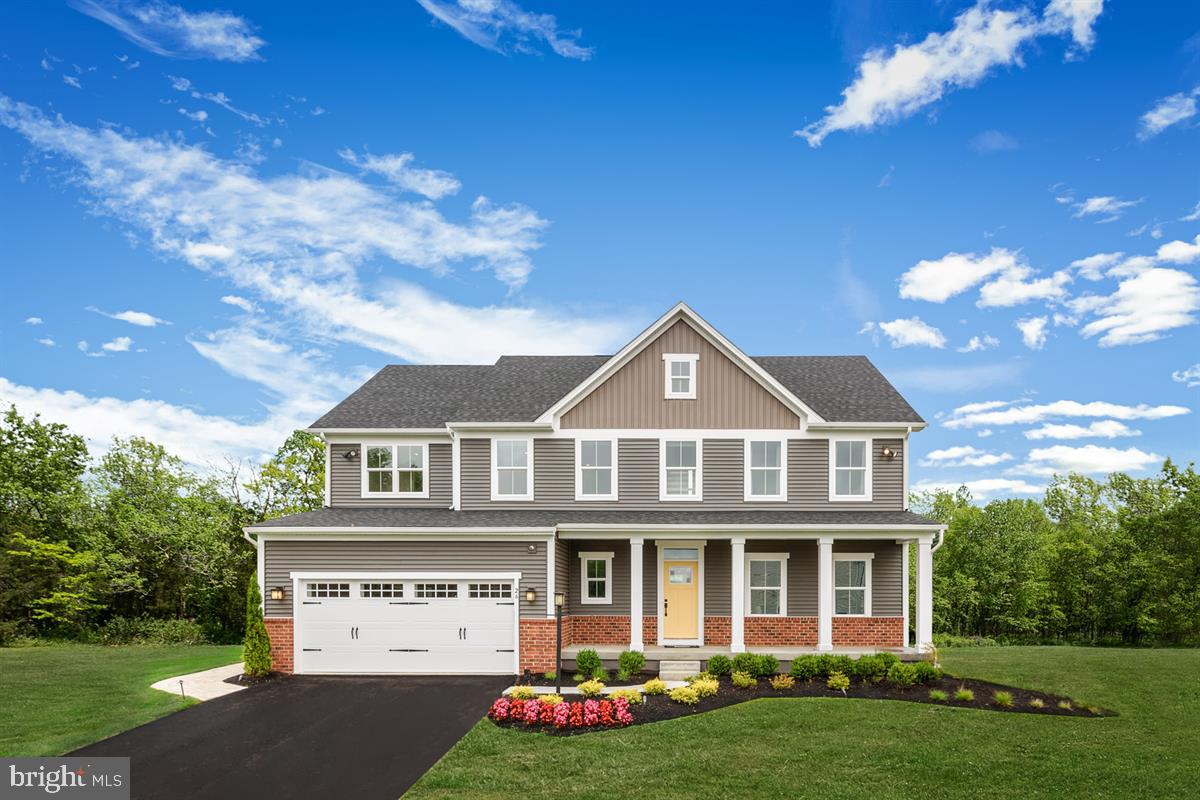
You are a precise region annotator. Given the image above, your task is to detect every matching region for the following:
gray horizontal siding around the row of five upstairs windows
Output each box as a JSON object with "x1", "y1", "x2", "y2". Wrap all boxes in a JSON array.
[{"x1": 458, "y1": 439, "x2": 904, "y2": 511}]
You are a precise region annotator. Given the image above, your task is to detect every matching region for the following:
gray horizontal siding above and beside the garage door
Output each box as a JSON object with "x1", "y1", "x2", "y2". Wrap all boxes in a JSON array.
[{"x1": 263, "y1": 540, "x2": 547, "y2": 618}]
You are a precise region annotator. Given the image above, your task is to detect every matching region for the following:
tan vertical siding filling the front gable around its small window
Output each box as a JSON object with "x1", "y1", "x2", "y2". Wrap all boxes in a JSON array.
[{"x1": 560, "y1": 320, "x2": 800, "y2": 429}]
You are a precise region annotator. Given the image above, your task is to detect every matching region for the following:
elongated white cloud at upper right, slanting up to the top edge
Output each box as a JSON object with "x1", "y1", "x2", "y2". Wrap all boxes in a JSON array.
[{"x1": 796, "y1": 0, "x2": 1102, "y2": 148}]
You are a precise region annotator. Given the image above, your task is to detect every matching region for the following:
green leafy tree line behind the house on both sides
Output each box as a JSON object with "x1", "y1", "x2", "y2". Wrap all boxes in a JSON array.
[{"x1": 0, "y1": 408, "x2": 1200, "y2": 644}]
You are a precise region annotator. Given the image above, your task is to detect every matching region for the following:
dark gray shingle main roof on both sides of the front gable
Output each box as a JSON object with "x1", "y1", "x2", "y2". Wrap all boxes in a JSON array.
[{"x1": 312, "y1": 355, "x2": 923, "y2": 428}]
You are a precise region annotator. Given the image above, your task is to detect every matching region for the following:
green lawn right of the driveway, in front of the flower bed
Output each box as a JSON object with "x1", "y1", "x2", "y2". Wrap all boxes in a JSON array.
[{"x1": 406, "y1": 648, "x2": 1200, "y2": 800}]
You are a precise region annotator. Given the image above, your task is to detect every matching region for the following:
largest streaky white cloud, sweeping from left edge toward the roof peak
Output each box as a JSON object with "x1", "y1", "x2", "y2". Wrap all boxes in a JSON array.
[{"x1": 0, "y1": 95, "x2": 631, "y2": 363}]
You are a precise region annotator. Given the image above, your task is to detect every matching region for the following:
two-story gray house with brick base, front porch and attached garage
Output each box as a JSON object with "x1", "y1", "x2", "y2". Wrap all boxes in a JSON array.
[{"x1": 246, "y1": 303, "x2": 942, "y2": 674}]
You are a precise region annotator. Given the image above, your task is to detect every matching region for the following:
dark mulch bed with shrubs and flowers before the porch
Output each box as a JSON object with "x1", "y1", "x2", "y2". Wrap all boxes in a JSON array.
[{"x1": 492, "y1": 675, "x2": 1116, "y2": 736}]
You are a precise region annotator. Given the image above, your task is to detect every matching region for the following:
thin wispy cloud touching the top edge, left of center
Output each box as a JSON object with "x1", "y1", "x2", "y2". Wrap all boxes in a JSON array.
[{"x1": 416, "y1": 0, "x2": 594, "y2": 61}]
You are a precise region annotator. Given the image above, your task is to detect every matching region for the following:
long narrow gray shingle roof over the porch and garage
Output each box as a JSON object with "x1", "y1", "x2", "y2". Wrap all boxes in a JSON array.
[{"x1": 253, "y1": 507, "x2": 938, "y2": 530}]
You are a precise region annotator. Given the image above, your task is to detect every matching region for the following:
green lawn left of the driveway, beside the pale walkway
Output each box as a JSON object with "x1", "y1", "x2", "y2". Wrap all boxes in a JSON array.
[{"x1": 0, "y1": 644, "x2": 241, "y2": 756}]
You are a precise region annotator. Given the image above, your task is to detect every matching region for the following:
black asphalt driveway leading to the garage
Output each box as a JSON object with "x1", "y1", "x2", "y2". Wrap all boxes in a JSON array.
[{"x1": 71, "y1": 675, "x2": 508, "y2": 800}]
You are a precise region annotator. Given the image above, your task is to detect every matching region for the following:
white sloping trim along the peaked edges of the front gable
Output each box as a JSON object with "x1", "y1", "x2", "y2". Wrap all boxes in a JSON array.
[{"x1": 538, "y1": 302, "x2": 824, "y2": 425}]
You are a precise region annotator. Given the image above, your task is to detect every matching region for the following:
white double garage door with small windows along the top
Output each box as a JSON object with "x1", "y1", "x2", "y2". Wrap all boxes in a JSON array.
[{"x1": 295, "y1": 577, "x2": 517, "y2": 675}]
